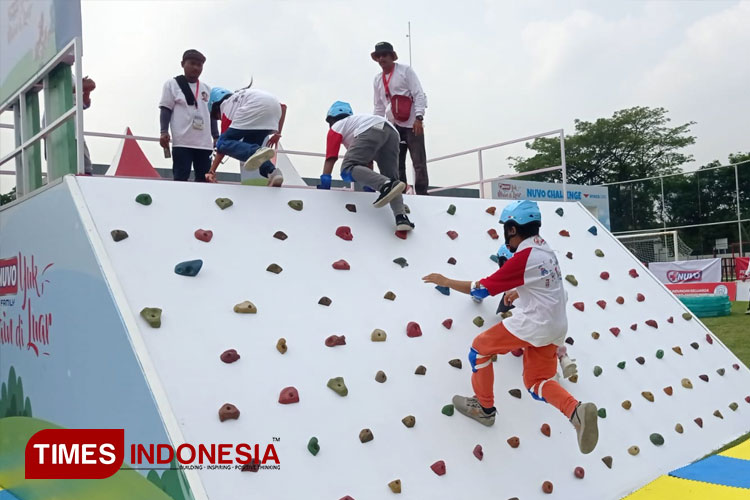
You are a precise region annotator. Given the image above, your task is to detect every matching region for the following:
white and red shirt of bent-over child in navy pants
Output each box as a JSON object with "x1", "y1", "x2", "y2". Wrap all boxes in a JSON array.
[{"x1": 221, "y1": 89, "x2": 281, "y2": 133}]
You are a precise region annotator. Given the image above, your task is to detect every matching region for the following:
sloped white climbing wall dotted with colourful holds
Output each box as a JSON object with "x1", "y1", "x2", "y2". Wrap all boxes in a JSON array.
[{"x1": 72, "y1": 178, "x2": 750, "y2": 500}]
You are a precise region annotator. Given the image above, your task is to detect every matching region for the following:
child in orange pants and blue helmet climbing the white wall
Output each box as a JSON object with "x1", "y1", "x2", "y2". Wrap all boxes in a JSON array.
[{"x1": 422, "y1": 200, "x2": 599, "y2": 453}]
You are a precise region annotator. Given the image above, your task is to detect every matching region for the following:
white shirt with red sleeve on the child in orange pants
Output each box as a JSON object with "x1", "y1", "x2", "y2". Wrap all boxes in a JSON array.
[{"x1": 479, "y1": 236, "x2": 568, "y2": 347}]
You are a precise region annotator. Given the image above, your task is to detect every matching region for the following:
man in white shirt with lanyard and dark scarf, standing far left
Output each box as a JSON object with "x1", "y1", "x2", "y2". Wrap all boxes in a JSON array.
[{"x1": 159, "y1": 49, "x2": 219, "y2": 182}]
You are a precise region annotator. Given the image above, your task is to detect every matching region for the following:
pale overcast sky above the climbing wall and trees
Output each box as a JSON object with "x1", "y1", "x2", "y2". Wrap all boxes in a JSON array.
[{"x1": 0, "y1": 0, "x2": 750, "y2": 192}]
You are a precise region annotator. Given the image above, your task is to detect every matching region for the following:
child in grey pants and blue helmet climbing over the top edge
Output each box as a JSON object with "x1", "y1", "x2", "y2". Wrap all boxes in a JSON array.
[{"x1": 318, "y1": 101, "x2": 414, "y2": 231}]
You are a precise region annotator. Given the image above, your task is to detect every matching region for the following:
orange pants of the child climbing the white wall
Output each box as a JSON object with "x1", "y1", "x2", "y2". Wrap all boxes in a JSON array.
[{"x1": 469, "y1": 322, "x2": 578, "y2": 418}]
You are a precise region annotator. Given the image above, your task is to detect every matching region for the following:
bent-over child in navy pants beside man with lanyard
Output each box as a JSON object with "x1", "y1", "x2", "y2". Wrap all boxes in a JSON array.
[{"x1": 206, "y1": 87, "x2": 286, "y2": 186}]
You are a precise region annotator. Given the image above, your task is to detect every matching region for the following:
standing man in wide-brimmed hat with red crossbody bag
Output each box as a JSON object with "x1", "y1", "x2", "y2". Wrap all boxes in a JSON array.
[{"x1": 370, "y1": 42, "x2": 429, "y2": 194}]
